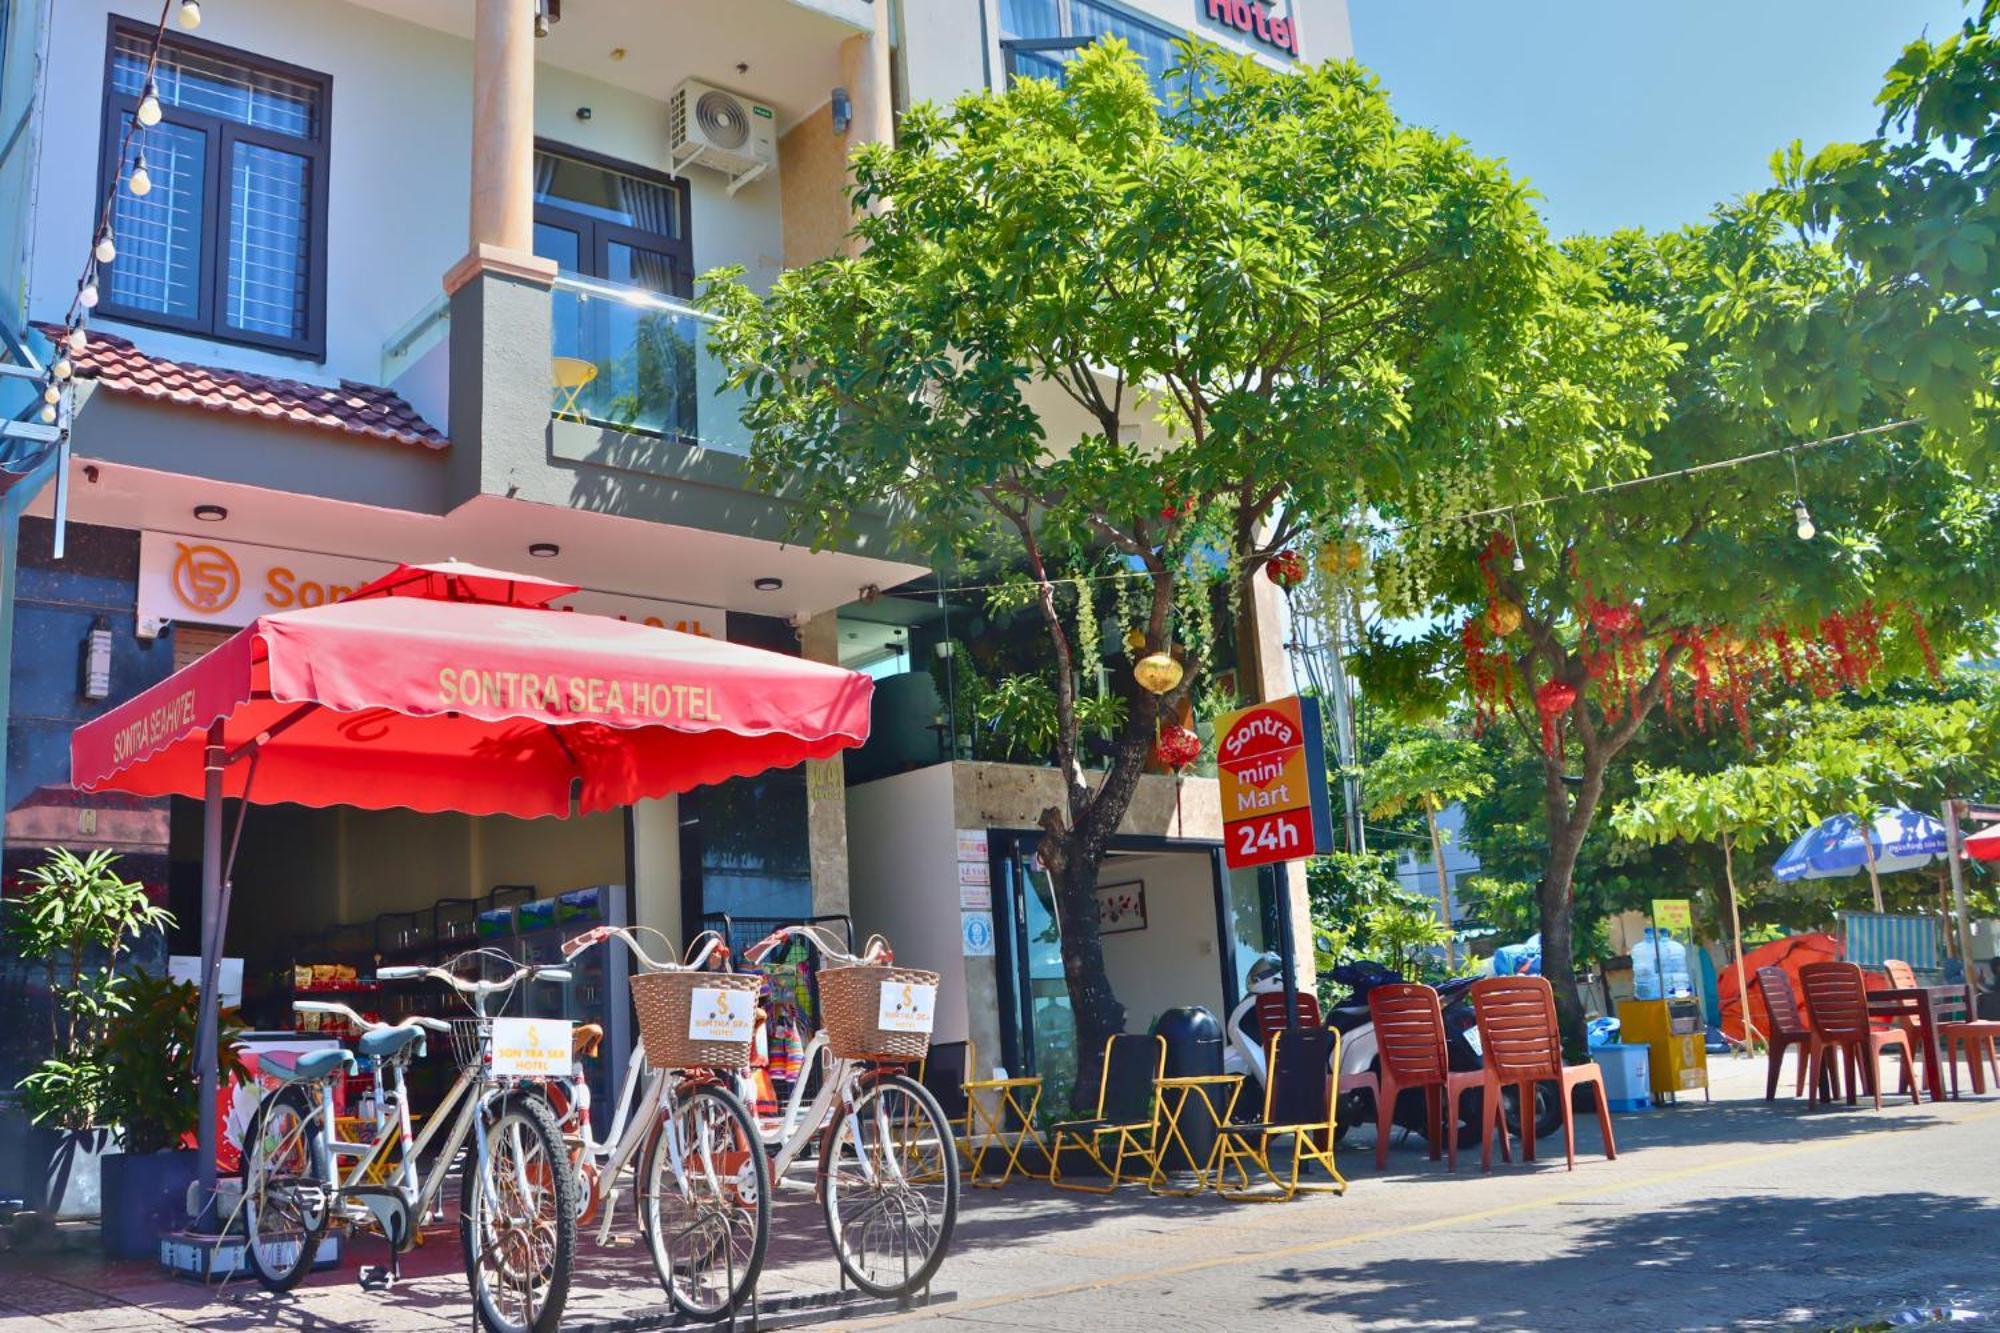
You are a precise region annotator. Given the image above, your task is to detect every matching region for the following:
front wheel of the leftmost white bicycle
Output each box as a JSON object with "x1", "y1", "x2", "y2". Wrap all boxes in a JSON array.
[{"x1": 458, "y1": 1093, "x2": 576, "y2": 1333}]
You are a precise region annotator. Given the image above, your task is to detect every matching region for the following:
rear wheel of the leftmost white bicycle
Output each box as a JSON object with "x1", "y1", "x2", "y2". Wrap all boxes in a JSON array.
[{"x1": 242, "y1": 1087, "x2": 330, "y2": 1291}]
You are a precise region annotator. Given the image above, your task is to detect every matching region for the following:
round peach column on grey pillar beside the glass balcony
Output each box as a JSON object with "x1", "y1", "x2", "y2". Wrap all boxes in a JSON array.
[{"x1": 444, "y1": 0, "x2": 556, "y2": 292}]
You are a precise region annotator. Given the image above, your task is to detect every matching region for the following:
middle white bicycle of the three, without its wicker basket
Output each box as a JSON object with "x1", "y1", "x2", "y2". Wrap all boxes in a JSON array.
[{"x1": 550, "y1": 927, "x2": 770, "y2": 1323}]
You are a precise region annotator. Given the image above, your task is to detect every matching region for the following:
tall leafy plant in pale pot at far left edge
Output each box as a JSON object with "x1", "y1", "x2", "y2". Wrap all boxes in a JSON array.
[{"x1": 0, "y1": 847, "x2": 172, "y2": 1217}]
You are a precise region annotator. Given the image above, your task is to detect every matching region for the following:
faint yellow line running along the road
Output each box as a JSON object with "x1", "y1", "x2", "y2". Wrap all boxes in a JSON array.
[{"x1": 846, "y1": 1107, "x2": 2000, "y2": 1329}]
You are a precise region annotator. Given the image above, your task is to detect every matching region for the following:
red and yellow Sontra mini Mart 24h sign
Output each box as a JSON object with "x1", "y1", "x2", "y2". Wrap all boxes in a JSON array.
[{"x1": 1216, "y1": 695, "x2": 1334, "y2": 867}]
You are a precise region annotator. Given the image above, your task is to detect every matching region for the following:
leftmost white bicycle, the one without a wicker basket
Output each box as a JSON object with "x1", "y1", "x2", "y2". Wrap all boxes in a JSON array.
[{"x1": 242, "y1": 949, "x2": 576, "y2": 1333}]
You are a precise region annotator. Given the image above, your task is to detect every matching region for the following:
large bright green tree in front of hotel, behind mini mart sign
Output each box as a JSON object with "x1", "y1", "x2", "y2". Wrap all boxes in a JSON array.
[{"x1": 704, "y1": 40, "x2": 1548, "y2": 1085}]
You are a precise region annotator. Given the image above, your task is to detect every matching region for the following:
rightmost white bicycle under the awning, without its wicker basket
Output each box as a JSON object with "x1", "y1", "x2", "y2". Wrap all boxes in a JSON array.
[{"x1": 744, "y1": 925, "x2": 958, "y2": 1297}]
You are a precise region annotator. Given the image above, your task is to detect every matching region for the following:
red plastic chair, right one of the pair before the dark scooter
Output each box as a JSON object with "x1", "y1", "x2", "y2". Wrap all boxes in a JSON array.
[{"x1": 1472, "y1": 977, "x2": 1618, "y2": 1171}]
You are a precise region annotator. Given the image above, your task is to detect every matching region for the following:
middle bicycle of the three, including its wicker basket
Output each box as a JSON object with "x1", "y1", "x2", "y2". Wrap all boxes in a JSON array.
[{"x1": 550, "y1": 927, "x2": 770, "y2": 1323}]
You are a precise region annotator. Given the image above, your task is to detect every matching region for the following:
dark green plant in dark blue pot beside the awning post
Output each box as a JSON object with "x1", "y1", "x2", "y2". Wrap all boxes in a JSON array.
[{"x1": 100, "y1": 973, "x2": 246, "y2": 1259}]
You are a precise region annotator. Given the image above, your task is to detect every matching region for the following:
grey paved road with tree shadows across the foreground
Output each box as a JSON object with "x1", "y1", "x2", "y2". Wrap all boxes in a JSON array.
[{"x1": 0, "y1": 1063, "x2": 2000, "y2": 1333}]
